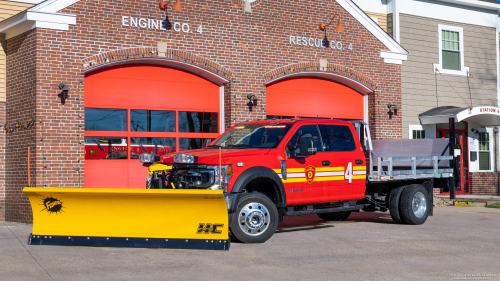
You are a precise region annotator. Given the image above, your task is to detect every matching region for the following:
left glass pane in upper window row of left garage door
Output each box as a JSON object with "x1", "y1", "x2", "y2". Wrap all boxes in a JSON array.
[{"x1": 85, "y1": 108, "x2": 127, "y2": 131}]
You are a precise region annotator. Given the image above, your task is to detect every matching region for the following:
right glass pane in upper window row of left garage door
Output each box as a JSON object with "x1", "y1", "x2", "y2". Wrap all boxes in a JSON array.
[{"x1": 179, "y1": 111, "x2": 219, "y2": 133}]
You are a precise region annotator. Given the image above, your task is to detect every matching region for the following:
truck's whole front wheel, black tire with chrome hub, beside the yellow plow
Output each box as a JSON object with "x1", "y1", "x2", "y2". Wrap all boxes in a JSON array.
[{"x1": 229, "y1": 192, "x2": 279, "y2": 243}]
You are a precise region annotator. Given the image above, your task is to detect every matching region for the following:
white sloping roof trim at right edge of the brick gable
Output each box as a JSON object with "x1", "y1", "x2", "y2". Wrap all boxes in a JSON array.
[{"x1": 335, "y1": 0, "x2": 408, "y2": 64}]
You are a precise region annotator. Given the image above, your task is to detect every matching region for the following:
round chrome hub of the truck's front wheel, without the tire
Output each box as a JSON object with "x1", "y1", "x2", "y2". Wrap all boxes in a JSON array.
[{"x1": 238, "y1": 202, "x2": 271, "y2": 236}]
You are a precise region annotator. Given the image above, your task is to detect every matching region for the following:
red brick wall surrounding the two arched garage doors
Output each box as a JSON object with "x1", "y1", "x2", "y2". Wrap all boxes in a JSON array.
[{"x1": 2, "y1": 0, "x2": 402, "y2": 221}]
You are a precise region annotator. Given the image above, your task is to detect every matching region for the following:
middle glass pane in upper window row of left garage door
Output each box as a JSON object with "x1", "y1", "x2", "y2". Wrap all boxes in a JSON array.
[{"x1": 130, "y1": 110, "x2": 175, "y2": 132}]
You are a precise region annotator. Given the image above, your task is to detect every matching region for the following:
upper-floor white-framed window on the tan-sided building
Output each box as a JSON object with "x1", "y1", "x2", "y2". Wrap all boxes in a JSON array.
[{"x1": 434, "y1": 24, "x2": 468, "y2": 75}]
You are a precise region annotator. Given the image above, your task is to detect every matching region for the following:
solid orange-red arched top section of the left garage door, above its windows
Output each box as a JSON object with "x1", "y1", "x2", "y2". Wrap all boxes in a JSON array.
[{"x1": 85, "y1": 65, "x2": 219, "y2": 111}]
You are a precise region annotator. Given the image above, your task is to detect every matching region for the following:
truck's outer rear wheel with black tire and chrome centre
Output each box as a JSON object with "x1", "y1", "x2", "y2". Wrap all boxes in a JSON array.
[{"x1": 399, "y1": 184, "x2": 431, "y2": 225}]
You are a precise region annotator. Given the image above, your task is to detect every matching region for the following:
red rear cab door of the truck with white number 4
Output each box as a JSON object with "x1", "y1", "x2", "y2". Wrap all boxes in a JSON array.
[{"x1": 316, "y1": 124, "x2": 366, "y2": 201}]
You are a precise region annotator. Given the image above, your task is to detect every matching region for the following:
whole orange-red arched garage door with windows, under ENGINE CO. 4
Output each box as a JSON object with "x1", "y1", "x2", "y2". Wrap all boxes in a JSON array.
[{"x1": 85, "y1": 64, "x2": 220, "y2": 188}]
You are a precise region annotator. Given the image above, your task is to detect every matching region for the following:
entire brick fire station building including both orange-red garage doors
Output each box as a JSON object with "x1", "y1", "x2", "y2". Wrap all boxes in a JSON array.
[{"x1": 0, "y1": 0, "x2": 498, "y2": 222}]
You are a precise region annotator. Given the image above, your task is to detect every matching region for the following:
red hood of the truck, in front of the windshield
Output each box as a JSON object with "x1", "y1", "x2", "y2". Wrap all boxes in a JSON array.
[{"x1": 161, "y1": 148, "x2": 269, "y2": 165}]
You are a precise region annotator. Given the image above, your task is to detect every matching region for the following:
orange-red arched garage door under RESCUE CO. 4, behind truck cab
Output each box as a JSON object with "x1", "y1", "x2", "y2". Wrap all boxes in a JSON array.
[{"x1": 266, "y1": 77, "x2": 364, "y2": 120}]
